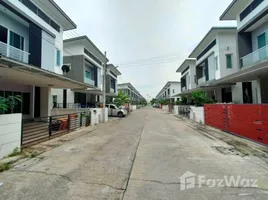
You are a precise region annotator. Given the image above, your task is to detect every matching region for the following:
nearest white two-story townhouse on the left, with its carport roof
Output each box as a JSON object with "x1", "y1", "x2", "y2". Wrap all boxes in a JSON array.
[{"x1": 0, "y1": 0, "x2": 88, "y2": 118}]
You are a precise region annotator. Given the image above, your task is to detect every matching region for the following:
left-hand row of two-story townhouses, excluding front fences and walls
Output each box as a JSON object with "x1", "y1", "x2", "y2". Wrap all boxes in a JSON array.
[{"x1": 0, "y1": 0, "x2": 144, "y2": 119}]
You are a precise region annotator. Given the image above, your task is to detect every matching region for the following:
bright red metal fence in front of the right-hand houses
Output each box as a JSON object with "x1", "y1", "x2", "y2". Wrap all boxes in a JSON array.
[{"x1": 205, "y1": 104, "x2": 268, "y2": 145}]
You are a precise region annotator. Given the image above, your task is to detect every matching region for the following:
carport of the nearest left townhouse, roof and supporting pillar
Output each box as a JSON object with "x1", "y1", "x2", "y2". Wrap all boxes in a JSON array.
[{"x1": 0, "y1": 56, "x2": 91, "y2": 118}]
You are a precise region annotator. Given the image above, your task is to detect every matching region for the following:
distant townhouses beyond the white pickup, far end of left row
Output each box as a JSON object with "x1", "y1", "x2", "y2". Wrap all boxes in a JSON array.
[{"x1": 117, "y1": 83, "x2": 146, "y2": 104}]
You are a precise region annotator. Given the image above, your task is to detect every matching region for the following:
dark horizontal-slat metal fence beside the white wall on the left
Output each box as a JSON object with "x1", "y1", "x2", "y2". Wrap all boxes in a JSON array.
[{"x1": 21, "y1": 111, "x2": 91, "y2": 148}]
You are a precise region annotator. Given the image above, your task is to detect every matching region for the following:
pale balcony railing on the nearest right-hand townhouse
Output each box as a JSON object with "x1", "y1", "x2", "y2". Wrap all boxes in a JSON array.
[{"x1": 241, "y1": 46, "x2": 268, "y2": 68}]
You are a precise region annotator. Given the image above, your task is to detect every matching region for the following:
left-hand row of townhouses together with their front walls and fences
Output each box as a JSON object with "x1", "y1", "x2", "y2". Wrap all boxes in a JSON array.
[{"x1": 0, "y1": 0, "x2": 147, "y2": 158}]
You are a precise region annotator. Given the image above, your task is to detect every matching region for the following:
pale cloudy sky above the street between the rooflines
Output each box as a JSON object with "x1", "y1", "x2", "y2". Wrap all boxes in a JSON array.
[{"x1": 55, "y1": 0, "x2": 235, "y2": 98}]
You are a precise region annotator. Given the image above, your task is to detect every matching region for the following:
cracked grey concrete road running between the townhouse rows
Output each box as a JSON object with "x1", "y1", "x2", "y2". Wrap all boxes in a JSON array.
[{"x1": 0, "y1": 108, "x2": 268, "y2": 200}]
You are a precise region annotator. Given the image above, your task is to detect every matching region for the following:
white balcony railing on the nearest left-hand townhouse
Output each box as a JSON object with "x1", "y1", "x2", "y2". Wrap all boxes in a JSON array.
[{"x1": 0, "y1": 42, "x2": 30, "y2": 64}]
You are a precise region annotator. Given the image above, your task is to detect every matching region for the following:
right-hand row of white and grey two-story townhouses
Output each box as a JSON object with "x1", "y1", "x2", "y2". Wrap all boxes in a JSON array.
[{"x1": 157, "y1": 0, "x2": 268, "y2": 104}]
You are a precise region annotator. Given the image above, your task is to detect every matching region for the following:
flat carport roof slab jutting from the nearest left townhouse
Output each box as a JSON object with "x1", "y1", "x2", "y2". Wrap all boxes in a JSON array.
[{"x1": 0, "y1": 55, "x2": 92, "y2": 89}]
